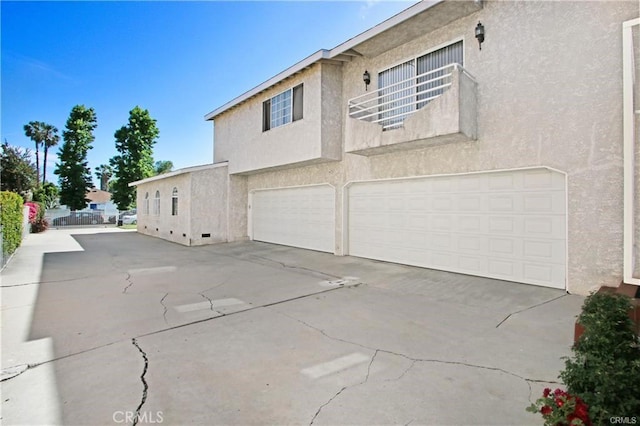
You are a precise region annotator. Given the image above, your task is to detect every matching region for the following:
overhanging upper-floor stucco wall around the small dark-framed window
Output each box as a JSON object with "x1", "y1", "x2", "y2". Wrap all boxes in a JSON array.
[{"x1": 214, "y1": 64, "x2": 341, "y2": 174}]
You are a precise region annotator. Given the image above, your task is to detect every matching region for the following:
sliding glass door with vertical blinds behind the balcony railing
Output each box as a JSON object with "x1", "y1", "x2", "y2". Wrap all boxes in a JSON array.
[{"x1": 378, "y1": 40, "x2": 464, "y2": 128}]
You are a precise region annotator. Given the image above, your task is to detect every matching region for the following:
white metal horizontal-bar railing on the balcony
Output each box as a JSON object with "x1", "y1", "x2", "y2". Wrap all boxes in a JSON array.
[{"x1": 349, "y1": 63, "x2": 473, "y2": 130}]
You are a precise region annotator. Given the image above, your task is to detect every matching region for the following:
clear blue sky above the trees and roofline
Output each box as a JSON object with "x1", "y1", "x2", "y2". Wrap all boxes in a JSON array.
[{"x1": 0, "y1": 0, "x2": 415, "y2": 183}]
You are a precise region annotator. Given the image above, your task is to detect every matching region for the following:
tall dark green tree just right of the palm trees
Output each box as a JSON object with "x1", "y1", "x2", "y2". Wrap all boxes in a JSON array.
[{"x1": 54, "y1": 105, "x2": 97, "y2": 210}]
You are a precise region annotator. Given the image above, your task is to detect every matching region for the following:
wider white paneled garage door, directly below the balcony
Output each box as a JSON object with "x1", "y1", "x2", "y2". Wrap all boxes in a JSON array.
[{"x1": 348, "y1": 168, "x2": 566, "y2": 288}]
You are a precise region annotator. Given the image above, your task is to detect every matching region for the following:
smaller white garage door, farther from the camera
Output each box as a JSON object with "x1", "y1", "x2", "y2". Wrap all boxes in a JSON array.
[{"x1": 251, "y1": 185, "x2": 335, "y2": 253}]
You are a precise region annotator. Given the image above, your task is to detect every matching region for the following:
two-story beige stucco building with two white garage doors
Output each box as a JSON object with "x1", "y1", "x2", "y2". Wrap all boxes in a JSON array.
[{"x1": 132, "y1": 0, "x2": 640, "y2": 294}]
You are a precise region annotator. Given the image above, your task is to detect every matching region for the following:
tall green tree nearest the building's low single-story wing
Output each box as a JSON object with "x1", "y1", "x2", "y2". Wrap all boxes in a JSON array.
[{"x1": 109, "y1": 106, "x2": 160, "y2": 210}]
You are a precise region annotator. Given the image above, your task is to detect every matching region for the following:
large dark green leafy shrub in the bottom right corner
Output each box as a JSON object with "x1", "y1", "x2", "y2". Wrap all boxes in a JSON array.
[{"x1": 560, "y1": 292, "x2": 640, "y2": 424}]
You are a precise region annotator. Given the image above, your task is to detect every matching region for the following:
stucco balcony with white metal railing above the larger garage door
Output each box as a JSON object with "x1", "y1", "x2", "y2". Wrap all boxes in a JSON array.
[{"x1": 345, "y1": 64, "x2": 477, "y2": 155}]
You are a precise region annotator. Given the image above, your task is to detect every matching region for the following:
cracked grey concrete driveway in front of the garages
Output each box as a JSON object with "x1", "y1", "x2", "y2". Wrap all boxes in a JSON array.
[{"x1": 1, "y1": 229, "x2": 583, "y2": 425}]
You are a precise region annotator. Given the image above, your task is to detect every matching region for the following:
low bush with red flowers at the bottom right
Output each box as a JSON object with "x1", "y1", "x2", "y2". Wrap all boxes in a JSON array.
[{"x1": 527, "y1": 388, "x2": 591, "y2": 426}]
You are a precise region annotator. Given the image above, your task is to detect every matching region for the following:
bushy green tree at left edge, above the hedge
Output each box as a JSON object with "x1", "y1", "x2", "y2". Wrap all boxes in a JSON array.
[{"x1": 0, "y1": 140, "x2": 38, "y2": 198}]
